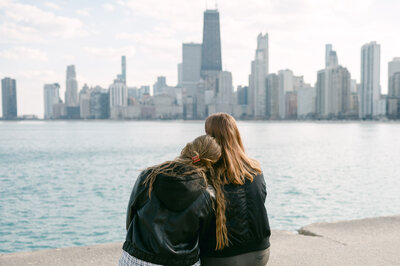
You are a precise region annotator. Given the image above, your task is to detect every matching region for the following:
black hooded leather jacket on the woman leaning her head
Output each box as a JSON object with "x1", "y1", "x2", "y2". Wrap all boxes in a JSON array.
[{"x1": 123, "y1": 166, "x2": 214, "y2": 265}]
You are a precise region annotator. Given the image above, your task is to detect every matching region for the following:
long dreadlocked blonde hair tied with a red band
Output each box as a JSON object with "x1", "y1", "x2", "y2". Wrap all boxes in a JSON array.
[{"x1": 143, "y1": 135, "x2": 228, "y2": 250}]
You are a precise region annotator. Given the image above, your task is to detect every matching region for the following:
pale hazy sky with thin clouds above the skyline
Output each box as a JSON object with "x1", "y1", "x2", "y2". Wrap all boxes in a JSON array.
[{"x1": 0, "y1": 0, "x2": 400, "y2": 116}]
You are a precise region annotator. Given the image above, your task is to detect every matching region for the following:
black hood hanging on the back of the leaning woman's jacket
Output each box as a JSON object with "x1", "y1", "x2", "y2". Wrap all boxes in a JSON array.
[{"x1": 154, "y1": 163, "x2": 206, "y2": 211}]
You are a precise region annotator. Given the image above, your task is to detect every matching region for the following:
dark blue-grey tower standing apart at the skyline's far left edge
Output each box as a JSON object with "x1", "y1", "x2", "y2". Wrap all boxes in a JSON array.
[{"x1": 1, "y1": 78, "x2": 17, "y2": 119}]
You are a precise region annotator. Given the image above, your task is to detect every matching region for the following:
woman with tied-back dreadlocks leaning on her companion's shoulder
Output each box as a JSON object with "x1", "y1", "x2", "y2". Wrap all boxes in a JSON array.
[{"x1": 119, "y1": 135, "x2": 227, "y2": 266}]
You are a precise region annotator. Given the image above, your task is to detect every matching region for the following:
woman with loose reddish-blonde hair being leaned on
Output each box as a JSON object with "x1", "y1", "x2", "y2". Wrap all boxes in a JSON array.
[{"x1": 201, "y1": 113, "x2": 271, "y2": 266}]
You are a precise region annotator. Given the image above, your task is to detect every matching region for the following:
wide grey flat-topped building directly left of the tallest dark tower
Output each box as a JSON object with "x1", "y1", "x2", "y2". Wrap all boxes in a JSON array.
[{"x1": 182, "y1": 43, "x2": 202, "y2": 97}]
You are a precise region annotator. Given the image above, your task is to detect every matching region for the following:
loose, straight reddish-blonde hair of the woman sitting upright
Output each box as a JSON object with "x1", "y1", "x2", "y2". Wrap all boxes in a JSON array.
[{"x1": 205, "y1": 113, "x2": 261, "y2": 185}]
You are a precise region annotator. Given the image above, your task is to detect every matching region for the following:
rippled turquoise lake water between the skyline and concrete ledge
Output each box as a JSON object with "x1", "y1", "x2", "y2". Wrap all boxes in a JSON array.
[{"x1": 0, "y1": 121, "x2": 400, "y2": 253}]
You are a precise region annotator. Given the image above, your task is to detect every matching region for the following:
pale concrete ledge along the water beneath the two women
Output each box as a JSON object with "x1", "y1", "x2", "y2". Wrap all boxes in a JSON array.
[{"x1": 0, "y1": 215, "x2": 400, "y2": 266}]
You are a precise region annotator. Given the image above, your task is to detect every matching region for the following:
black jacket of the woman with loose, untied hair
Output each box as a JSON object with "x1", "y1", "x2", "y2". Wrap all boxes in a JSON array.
[{"x1": 201, "y1": 174, "x2": 271, "y2": 257}]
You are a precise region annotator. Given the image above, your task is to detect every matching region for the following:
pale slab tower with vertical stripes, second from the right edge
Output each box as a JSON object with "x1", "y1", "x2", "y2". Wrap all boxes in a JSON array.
[{"x1": 359, "y1": 42, "x2": 381, "y2": 119}]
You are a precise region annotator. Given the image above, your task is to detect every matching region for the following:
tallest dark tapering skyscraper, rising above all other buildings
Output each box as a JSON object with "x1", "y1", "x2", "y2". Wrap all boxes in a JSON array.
[{"x1": 201, "y1": 10, "x2": 222, "y2": 71}]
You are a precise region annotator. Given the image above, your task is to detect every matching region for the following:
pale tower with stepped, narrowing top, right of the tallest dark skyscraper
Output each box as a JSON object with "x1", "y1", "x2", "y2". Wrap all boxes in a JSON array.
[{"x1": 249, "y1": 33, "x2": 268, "y2": 118}]
